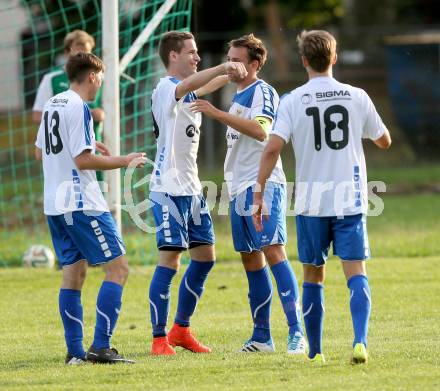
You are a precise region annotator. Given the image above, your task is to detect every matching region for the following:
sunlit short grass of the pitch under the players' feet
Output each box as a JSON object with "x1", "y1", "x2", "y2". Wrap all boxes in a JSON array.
[{"x1": 0, "y1": 258, "x2": 440, "y2": 391}]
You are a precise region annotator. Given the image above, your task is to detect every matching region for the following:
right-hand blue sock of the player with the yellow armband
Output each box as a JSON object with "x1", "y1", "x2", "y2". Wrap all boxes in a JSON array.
[{"x1": 272, "y1": 259, "x2": 303, "y2": 334}]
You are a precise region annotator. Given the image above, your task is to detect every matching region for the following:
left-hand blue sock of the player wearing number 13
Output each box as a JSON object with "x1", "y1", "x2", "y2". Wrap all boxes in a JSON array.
[{"x1": 58, "y1": 289, "x2": 86, "y2": 358}]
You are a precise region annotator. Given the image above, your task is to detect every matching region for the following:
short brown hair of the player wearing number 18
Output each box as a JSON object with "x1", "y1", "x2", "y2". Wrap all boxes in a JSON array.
[{"x1": 296, "y1": 30, "x2": 336, "y2": 72}]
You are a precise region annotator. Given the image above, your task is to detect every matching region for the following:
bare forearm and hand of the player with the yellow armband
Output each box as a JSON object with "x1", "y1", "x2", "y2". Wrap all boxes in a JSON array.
[{"x1": 190, "y1": 99, "x2": 271, "y2": 141}]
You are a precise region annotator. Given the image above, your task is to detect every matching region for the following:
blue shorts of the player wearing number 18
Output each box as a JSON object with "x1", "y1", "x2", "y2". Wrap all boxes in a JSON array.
[{"x1": 296, "y1": 214, "x2": 370, "y2": 266}]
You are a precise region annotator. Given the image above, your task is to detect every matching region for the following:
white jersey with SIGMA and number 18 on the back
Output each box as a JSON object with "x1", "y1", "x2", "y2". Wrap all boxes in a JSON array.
[{"x1": 272, "y1": 77, "x2": 386, "y2": 216}]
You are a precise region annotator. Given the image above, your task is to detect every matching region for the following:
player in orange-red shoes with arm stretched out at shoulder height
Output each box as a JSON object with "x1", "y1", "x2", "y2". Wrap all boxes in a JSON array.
[{"x1": 149, "y1": 31, "x2": 246, "y2": 355}]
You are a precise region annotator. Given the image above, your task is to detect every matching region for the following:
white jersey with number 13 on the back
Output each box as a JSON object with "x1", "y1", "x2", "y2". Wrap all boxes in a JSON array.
[{"x1": 35, "y1": 90, "x2": 109, "y2": 216}]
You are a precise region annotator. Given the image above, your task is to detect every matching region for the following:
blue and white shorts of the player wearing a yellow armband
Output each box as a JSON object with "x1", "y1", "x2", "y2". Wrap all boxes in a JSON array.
[{"x1": 229, "y1": 182, "x2": 287, "y2": 253}]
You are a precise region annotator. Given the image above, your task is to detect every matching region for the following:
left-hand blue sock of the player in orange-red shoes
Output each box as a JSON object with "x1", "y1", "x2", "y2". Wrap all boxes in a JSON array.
[{"x1": 149, "y1": 265, "x2": 176, "y2": 337}]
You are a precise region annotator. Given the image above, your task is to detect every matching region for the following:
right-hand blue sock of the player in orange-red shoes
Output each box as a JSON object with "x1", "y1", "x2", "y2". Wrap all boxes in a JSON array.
[{"x1": 175, "y1": 260, "x2": 214, "y2": 327}]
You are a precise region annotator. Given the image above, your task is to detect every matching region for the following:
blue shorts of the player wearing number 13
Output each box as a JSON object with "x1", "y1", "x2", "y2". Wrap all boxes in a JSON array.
[{"x1": 47, "y1": 211, "x2": 125, "y2": 267}]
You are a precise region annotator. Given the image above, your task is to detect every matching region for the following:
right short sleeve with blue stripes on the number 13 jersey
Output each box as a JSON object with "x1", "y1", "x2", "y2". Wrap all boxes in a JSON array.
[{"x1": 66, "y1": 103, "x2": 93, "y2": 158}]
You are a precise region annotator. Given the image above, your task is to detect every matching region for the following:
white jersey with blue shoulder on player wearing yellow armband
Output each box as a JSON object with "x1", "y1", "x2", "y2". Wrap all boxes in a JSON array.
[{"x1": 224, "y1": 79, "x2": 286, "y2": 199}]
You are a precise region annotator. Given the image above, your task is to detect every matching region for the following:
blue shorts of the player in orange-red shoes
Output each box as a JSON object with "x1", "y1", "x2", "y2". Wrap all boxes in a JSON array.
[{"x1": 149, "y1": 192, "x2": 215, "y2": 250}]
